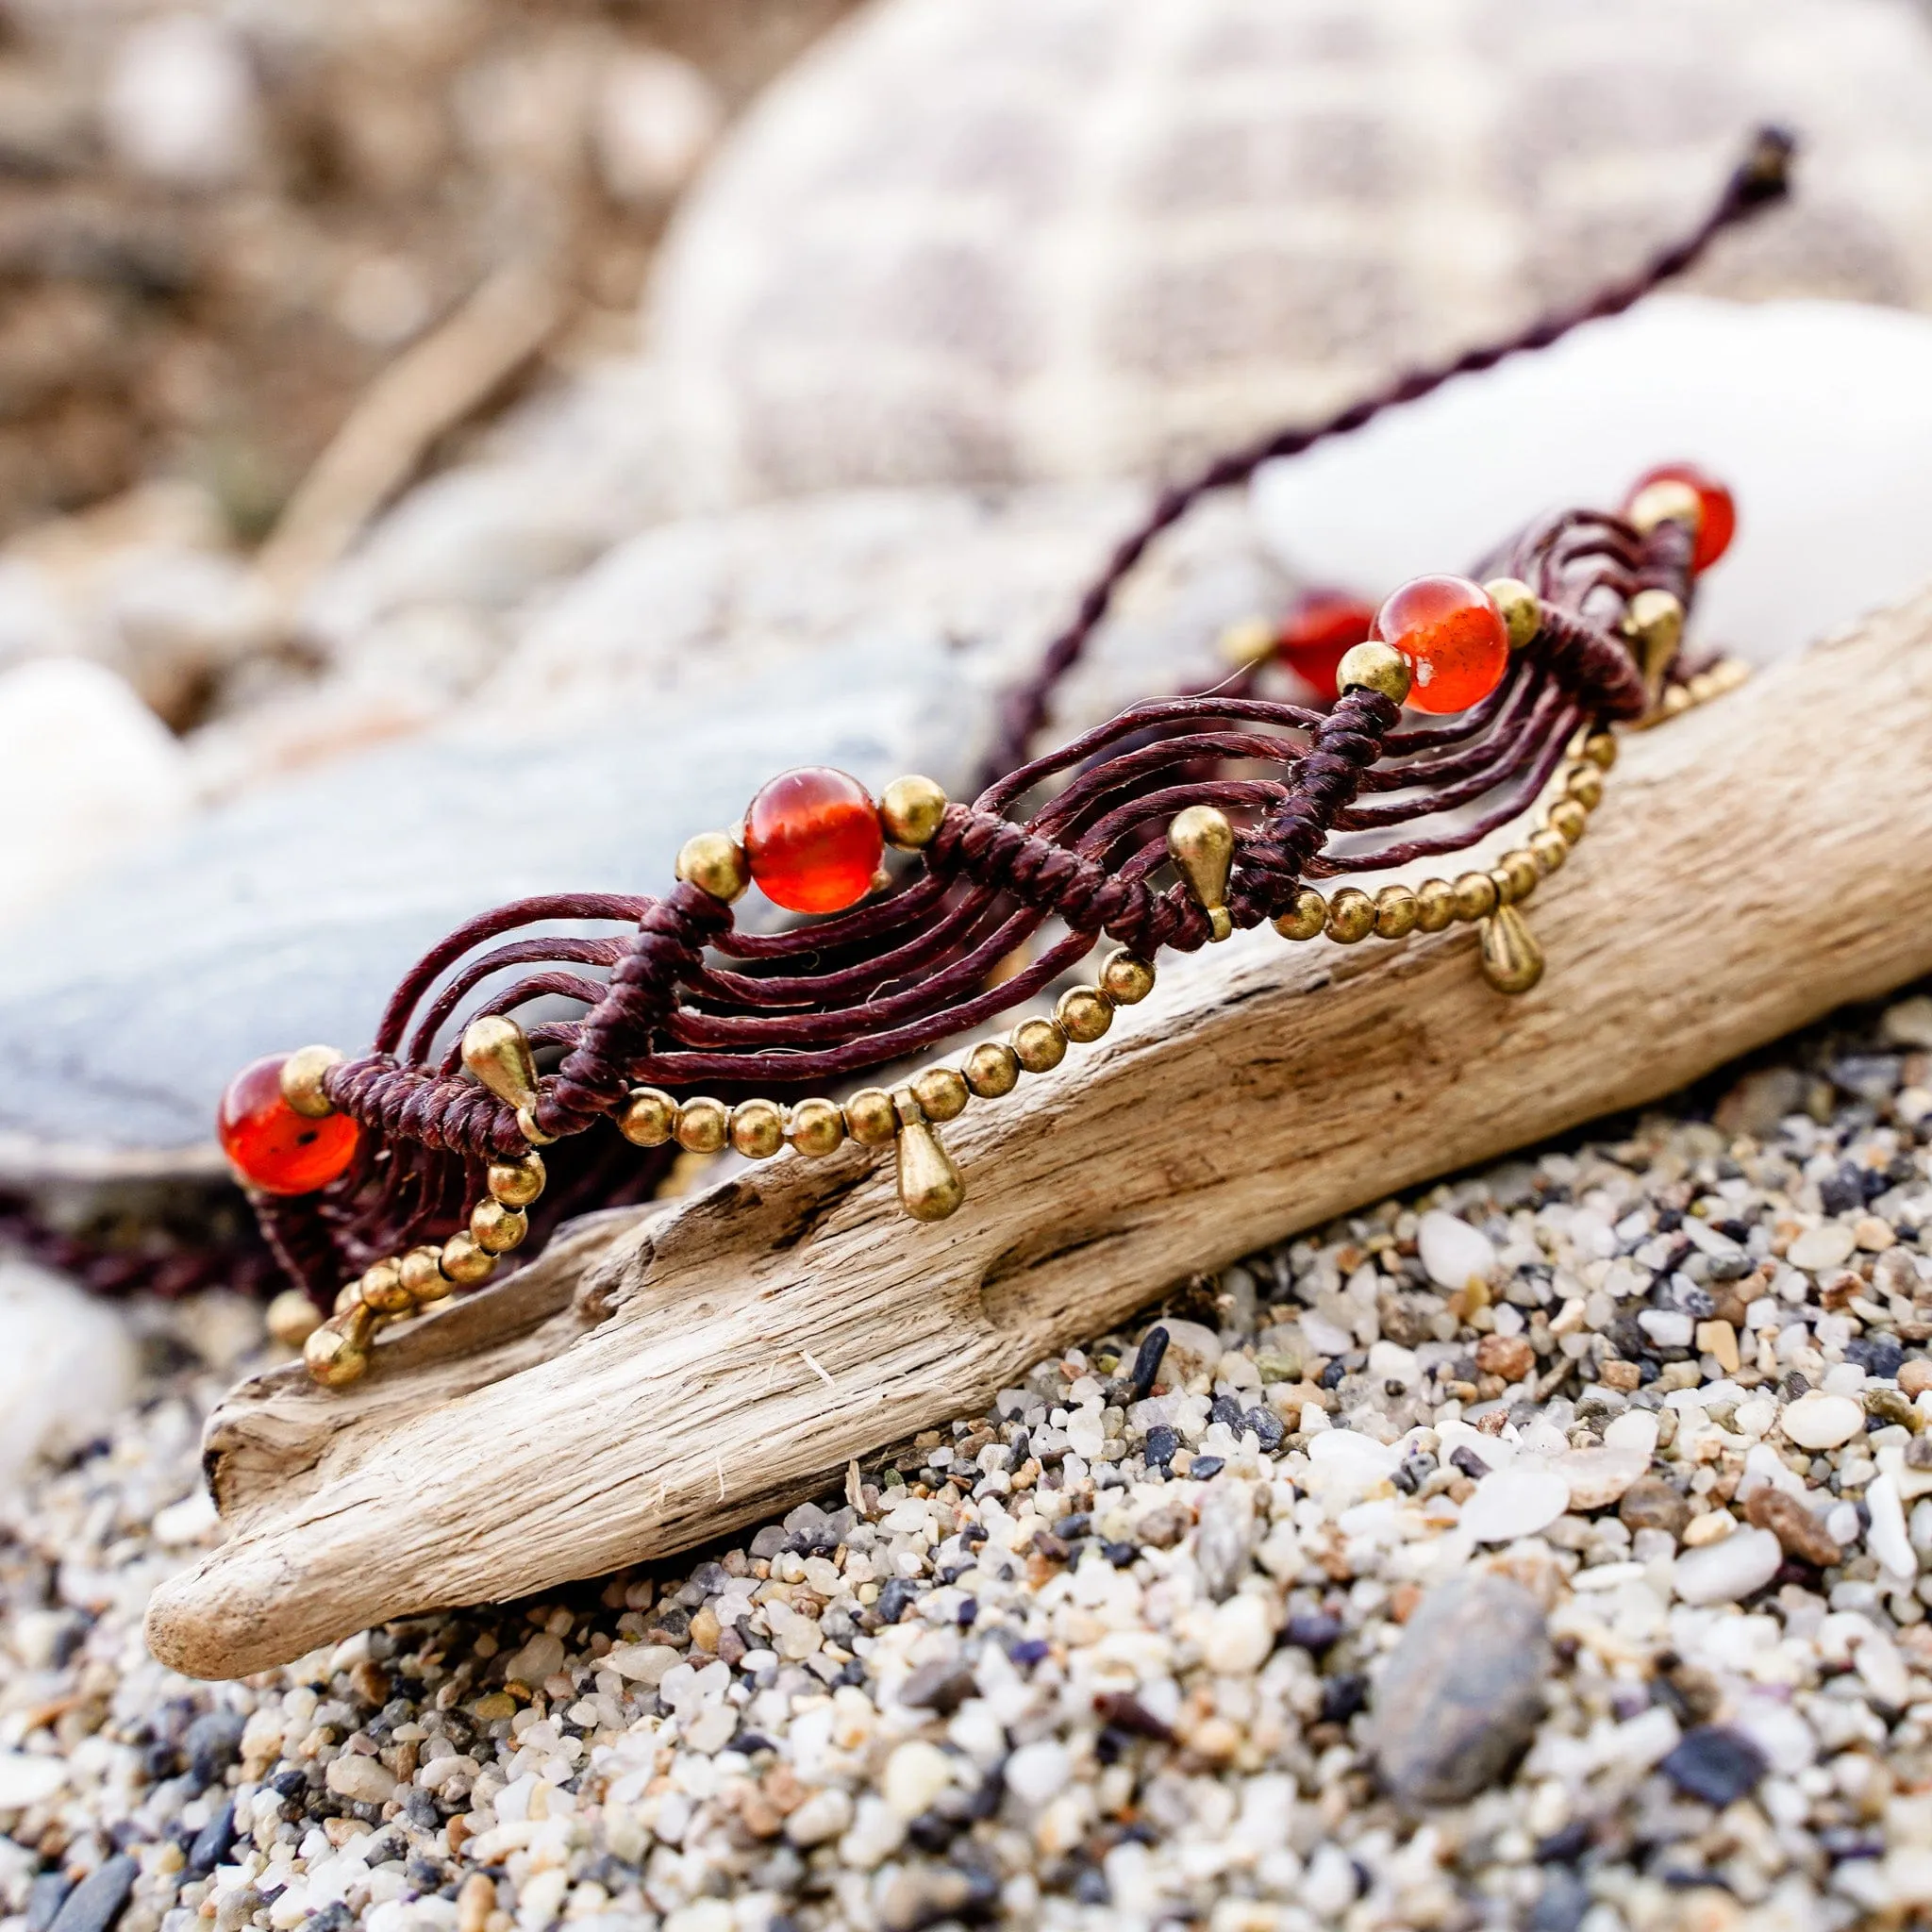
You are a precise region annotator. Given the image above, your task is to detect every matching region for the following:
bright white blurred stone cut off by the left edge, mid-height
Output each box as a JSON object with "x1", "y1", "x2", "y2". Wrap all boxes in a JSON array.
[{"x1": 0, "y1": 657, "x2": 192, "y2": 922}]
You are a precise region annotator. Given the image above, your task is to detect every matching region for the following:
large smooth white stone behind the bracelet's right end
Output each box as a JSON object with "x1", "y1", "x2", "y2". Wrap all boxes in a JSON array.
[{"x1": 1254, "y1": 295, "x2": 1932, "y2": 660}]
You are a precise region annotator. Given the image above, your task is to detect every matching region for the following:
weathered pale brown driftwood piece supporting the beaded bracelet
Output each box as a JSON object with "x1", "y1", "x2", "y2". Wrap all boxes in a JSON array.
[{"x1": 147, "y1": 593, "x2": 1932, "y2": 1677}]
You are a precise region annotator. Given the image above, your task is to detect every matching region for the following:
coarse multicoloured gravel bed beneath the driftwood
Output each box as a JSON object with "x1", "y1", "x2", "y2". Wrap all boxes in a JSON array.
[{"x1": 0, "y1": 995, "x2": 1932, "y2": 1932}]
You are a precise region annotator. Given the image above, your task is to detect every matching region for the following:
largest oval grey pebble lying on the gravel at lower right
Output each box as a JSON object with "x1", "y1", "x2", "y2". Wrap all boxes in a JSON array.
[{"x1": 1374, "y1": 1571, "x2": 1549, "y2": 1807}]
